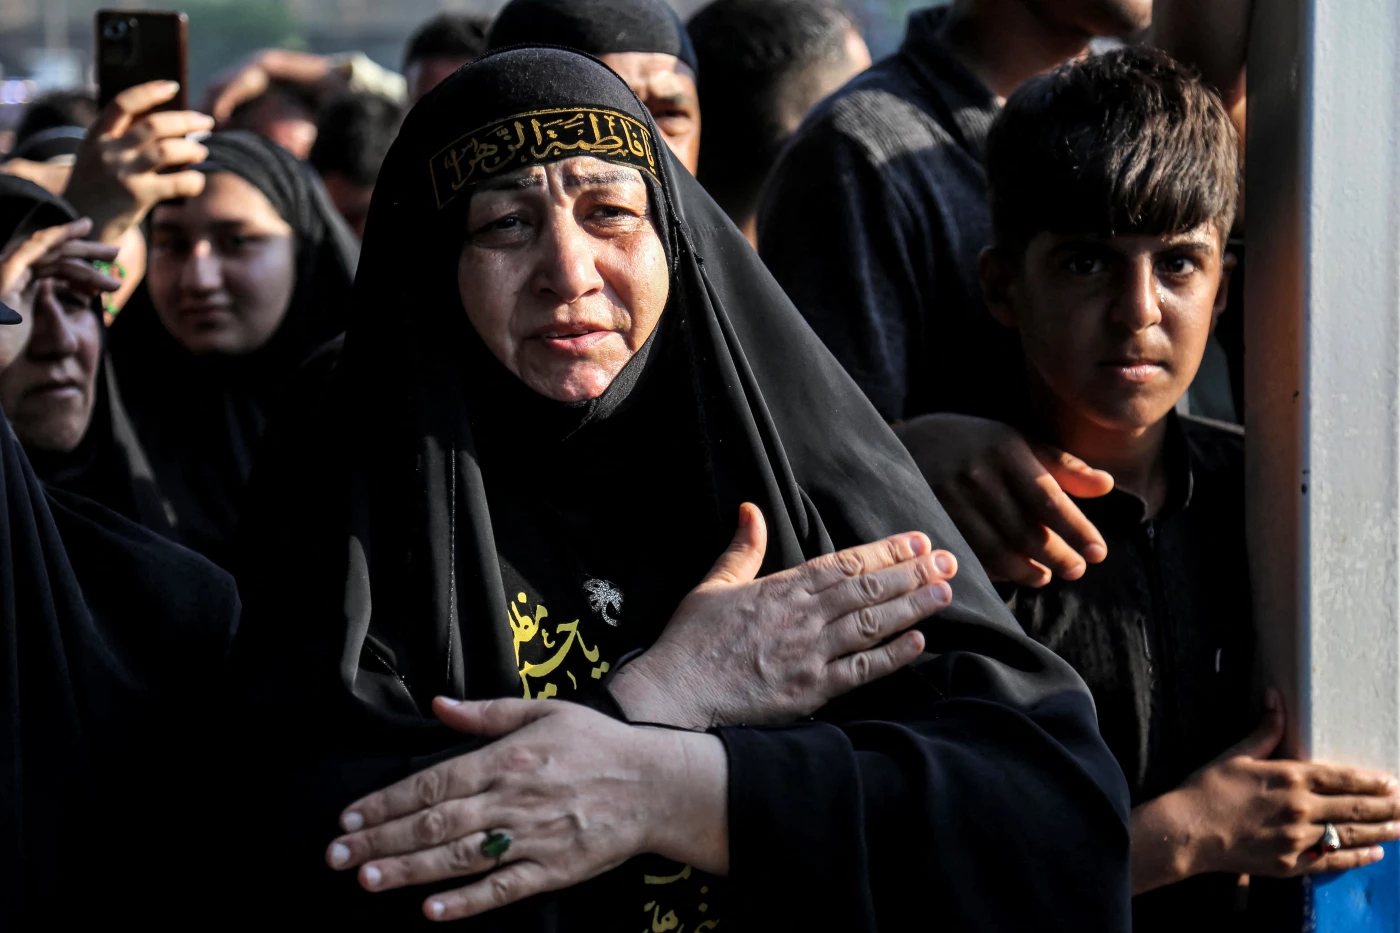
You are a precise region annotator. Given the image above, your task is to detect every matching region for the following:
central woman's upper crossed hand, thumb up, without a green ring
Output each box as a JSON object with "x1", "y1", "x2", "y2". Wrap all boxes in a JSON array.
[{"x1": 609, "y1": 503, "x2": 958, "y2": 728}]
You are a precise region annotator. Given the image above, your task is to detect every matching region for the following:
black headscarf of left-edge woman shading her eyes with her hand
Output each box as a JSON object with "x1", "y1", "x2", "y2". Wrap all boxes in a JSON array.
[{"x1": 0, "y1": 175, "x2": 175, "y2": 538}]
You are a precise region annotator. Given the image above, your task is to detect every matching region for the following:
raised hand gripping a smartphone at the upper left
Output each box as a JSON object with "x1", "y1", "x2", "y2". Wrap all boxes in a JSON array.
[{"x1": 64, "y1": 81, "x2": 214, "y2": 244}]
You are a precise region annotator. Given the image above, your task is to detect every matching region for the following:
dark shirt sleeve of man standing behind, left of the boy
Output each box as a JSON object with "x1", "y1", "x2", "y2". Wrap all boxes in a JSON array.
[{"x1": 759, "y1": 125, "x2": 927, "y2": 422}]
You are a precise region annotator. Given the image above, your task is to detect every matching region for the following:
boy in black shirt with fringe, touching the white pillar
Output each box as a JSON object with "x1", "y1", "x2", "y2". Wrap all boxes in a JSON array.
[{"x1": 965, "y1": 49, "x2": 1400, "y2": 932}]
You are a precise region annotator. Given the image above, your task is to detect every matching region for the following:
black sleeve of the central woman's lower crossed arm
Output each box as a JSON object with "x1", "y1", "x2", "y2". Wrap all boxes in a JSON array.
[{"x1": 718, "y1": 638, "x2": 1130, "y2": 933}]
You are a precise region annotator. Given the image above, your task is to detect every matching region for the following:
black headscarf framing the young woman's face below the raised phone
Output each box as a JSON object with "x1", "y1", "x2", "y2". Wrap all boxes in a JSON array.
[{"x1": 111, "y1": 132, "x2": 358, "y2": 562}]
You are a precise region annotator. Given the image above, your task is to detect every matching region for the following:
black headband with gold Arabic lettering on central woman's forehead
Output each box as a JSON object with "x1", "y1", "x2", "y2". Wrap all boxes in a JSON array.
[{"x1": 428, "y1": 106, "x2": 657, "y2": 210}]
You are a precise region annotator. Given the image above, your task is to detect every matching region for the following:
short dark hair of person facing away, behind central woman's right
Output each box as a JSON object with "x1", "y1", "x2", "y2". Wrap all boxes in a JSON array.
[{"x1": 686, "y1": 0, "x2": 851, "y2": 216}]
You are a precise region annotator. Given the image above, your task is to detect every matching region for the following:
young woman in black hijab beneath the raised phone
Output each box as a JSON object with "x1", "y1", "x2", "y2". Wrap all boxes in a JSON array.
[{"x1": 112, "y1": 132, "x2": 357, "y2": 562}]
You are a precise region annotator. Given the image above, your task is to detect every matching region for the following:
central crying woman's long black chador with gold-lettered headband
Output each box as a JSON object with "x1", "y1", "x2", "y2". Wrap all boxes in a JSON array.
[{"x1": 226, "y1": 49, "x2": 1128, "y2": 933}]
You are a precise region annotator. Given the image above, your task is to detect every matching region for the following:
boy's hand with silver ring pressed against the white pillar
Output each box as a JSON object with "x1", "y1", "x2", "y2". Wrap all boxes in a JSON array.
[{"x1": 1133, "y1": 691, "x2": 1400, "y2": 894}]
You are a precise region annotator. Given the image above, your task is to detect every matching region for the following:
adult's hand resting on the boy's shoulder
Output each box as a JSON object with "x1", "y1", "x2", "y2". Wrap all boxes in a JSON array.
[{"x1": 895, "y1": 415, "x2": 1113, "y2": 587}]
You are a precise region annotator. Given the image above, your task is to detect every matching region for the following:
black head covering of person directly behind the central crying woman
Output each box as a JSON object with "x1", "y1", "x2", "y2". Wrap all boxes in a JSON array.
[{"x1": 486, "y1": 0, "x2": 700, "y2": 71}]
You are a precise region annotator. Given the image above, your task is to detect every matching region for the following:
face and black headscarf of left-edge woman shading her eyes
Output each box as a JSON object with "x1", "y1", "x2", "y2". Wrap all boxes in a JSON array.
[{"x1": 0, "y1": 175, "x2": 175, "y2": 529}]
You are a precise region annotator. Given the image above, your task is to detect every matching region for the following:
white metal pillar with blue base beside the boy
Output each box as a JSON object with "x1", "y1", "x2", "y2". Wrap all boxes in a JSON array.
[{"x1": 1245, "y1": 0, "x2": 1400, "y2": 933}]
